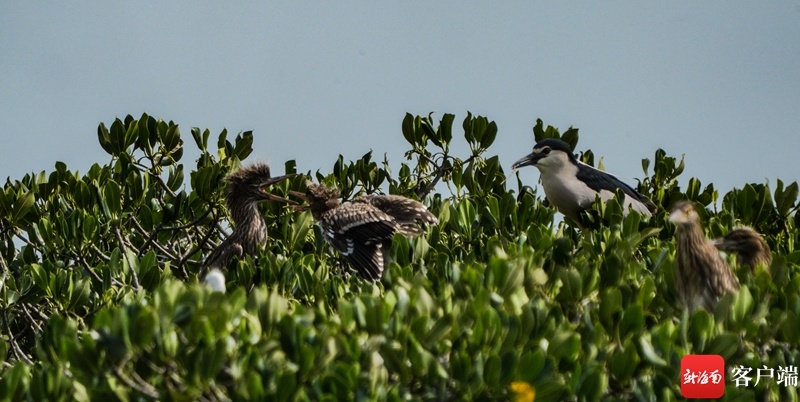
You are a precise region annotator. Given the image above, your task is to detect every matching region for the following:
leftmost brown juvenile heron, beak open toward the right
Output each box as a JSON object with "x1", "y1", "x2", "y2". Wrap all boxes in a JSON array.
[{"x1": 202, "y1": 163, "x2": 296, "y2": 272}]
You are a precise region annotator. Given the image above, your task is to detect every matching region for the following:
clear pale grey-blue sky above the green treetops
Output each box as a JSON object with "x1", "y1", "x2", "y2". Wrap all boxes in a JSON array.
[{"x1": 0, "y1": 0, "x2": 800, "y2": 199}]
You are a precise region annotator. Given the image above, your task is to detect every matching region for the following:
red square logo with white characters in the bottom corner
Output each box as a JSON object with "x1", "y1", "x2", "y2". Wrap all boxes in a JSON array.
[{"x1": 680, "y1": 355, "x2": 725, "y2": 399}]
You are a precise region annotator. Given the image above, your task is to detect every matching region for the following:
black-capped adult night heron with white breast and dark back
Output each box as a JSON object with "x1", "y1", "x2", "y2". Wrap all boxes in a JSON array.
[{"x1": 511, "y1": 138, "x2": 656, "y2": 224}]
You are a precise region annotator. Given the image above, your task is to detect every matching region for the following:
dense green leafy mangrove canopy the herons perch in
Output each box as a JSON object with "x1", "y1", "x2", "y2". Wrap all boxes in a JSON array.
[{"x1": 0, "y1": 114, "x2": 800, "y2": 401}]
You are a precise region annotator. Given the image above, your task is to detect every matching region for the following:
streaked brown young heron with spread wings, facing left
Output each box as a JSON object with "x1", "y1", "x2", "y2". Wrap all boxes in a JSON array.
[{"x1": 290, "y1": 182, "x2": 439, "y2": 282}]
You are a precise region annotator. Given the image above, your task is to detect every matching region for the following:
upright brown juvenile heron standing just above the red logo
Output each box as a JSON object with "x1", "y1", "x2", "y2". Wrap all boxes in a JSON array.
[{"x1": 669, "y1": 201, "x2": 739, "y2": 311}]
